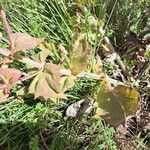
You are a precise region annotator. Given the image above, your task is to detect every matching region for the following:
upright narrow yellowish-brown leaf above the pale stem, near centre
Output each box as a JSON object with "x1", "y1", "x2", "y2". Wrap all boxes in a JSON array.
[{"x1": 70, "y1": 33, "x2": 92, "y2": 75}]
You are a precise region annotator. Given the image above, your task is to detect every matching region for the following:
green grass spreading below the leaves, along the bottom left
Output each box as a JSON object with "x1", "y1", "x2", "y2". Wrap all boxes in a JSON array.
[{"x1": 0, "y1": 78, "x2": 117, "y2": 150}]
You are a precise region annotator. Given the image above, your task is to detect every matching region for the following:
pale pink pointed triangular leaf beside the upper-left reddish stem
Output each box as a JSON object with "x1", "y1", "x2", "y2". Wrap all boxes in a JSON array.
[{"x1": 12, "y1": 33, "x2": 44, "y2": 53}]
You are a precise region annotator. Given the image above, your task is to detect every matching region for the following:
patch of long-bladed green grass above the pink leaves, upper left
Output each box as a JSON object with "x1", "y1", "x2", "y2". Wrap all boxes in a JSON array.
[{"x1": 1, "y1": 0, "x2": 72, "y2": 42}]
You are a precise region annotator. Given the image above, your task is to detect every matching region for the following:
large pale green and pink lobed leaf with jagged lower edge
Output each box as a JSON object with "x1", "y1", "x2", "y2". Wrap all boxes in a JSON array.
[{"x1": 29, "y1": 63, "x2": 75, "y2": 101}]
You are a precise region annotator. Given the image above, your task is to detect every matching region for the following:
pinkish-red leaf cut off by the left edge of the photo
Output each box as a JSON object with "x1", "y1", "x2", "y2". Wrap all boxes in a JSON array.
[{"x1": 0, "y1": 68, "x2": 21, "y2": 101}]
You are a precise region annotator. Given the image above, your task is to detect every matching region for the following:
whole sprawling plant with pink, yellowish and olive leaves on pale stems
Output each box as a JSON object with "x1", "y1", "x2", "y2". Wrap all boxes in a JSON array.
[{"x1": 0, "y1": 10, "x2": 140, "y2": 126}]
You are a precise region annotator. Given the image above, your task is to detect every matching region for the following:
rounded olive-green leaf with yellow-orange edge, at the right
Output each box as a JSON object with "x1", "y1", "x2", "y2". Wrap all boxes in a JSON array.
[{"x1": 97, "y1": 81, "x2": 140, "y2": 126}]
